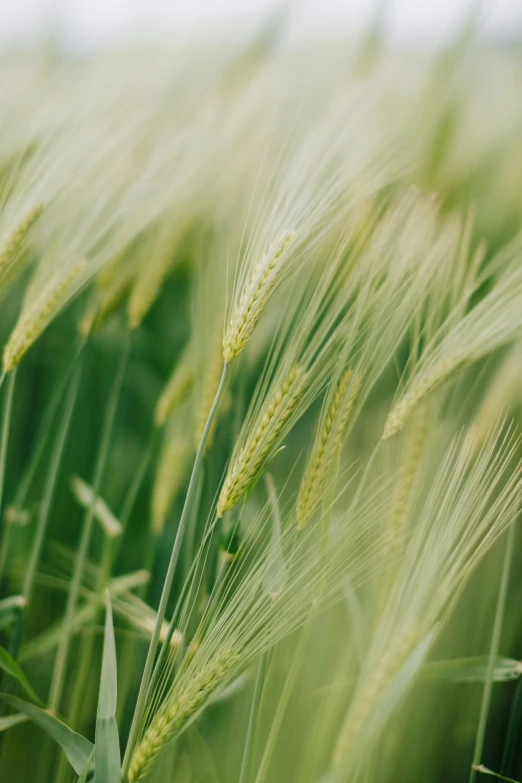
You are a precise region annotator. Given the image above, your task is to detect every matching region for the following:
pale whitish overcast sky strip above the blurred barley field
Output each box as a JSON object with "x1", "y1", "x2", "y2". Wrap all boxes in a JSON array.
[{"x1": 0, "y1": 0, "x2": 522, "y2": 47}]
